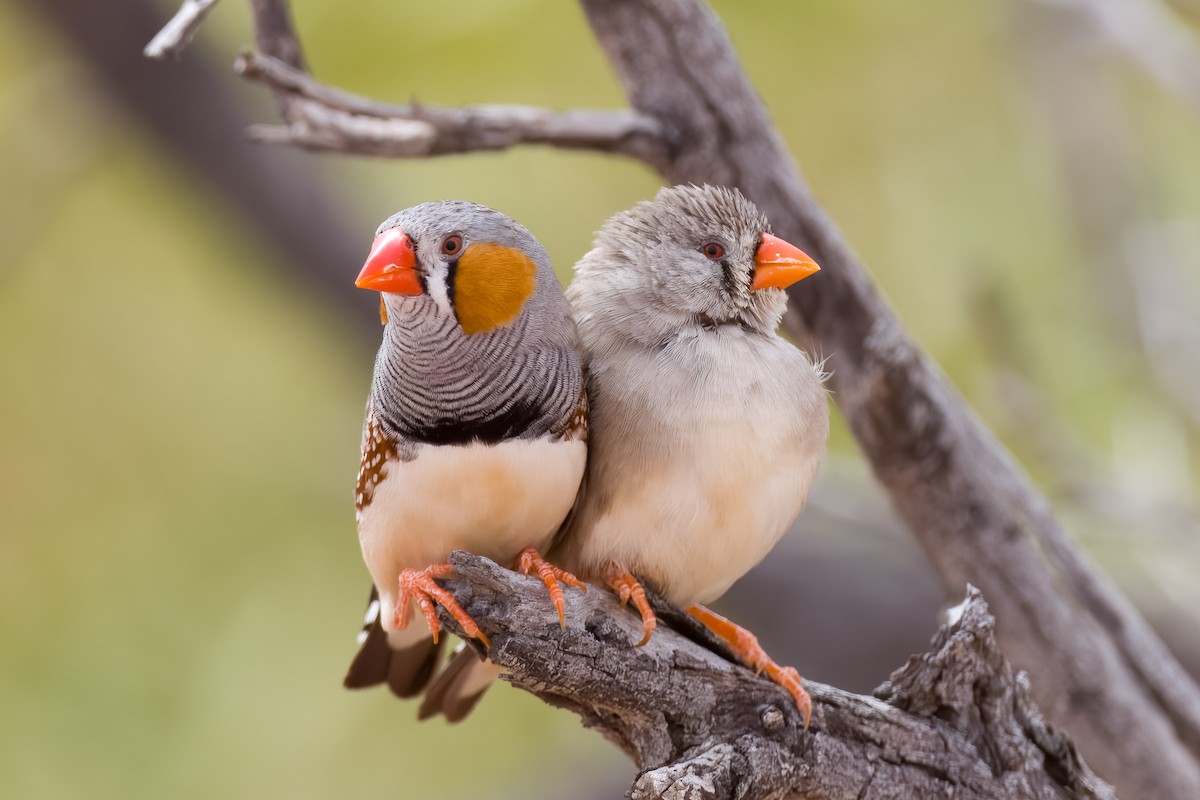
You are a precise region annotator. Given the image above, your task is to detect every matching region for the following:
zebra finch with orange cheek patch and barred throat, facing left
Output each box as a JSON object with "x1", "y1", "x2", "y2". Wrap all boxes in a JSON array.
[{"x1": 343, "y1": 200, "x2": 588, "y2": 714}]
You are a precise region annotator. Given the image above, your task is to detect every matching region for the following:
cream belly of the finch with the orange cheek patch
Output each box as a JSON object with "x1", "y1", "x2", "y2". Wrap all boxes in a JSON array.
[{"x1": 359, "y1": 439, "x2": 587, "y2": 646}]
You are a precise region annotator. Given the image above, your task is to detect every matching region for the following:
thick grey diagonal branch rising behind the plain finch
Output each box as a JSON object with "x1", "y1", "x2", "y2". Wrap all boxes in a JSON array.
[{"x1": 583, "y1": 0, "x2": 1200, "y2": 800}]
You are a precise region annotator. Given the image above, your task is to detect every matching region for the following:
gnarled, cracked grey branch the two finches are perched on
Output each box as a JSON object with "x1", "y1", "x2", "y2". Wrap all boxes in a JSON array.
[{"x1": 443, "y1": 553, "x2": 1114, "y2": 800}]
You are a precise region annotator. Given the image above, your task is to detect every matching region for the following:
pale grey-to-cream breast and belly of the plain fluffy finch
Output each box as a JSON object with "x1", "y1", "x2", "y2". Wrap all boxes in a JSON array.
[{"x1": 563, "y1": 321, "x2": 828, "y2": 606}]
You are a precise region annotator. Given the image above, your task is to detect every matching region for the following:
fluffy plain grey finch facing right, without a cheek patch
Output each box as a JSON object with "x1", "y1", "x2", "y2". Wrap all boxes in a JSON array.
[{"x1": 426, "y1": 186, "x2": 829, "y2": 727}]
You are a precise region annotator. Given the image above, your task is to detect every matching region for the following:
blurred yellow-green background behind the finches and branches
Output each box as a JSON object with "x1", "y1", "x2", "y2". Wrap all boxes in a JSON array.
[{"x1": 0, "y1": 0, "x2": 1200, "y2": 799}]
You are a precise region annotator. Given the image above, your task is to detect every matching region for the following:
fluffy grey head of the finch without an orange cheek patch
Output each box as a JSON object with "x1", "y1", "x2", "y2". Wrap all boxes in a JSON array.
[{"x1": 568, "y1": 186, "x2": 816, "y2": 344}]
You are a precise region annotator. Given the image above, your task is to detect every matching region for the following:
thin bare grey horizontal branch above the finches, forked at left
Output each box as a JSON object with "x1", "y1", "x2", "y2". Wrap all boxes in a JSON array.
[{"x1": 234, "y1": 53, "x2": 661, "y2": 160}]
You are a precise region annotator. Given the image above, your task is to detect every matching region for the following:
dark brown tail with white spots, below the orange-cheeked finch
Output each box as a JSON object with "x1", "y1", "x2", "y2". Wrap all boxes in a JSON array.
[{"x1": 342, "y1": 587, "x2": 442, "y2": 697}]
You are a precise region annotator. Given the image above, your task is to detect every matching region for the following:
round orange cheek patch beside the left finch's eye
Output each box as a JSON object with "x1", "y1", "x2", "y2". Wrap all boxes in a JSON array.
[{"x1": 454, "y1": 242, "x2": 538, "y2": 333}]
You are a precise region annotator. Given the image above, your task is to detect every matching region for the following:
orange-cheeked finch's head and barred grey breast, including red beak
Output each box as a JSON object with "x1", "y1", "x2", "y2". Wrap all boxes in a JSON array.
[{"x1": 356, "y1": 200, "x2": 583, "y2": 445}]
